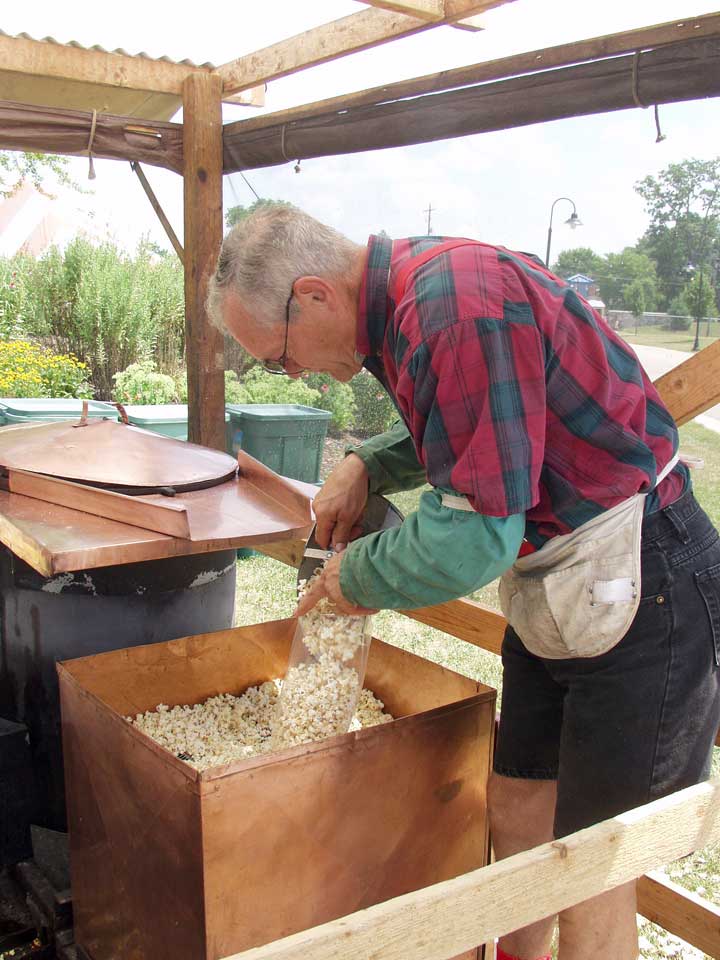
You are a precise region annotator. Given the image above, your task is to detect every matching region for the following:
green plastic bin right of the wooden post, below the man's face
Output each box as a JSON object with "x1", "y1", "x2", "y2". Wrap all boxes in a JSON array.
[{"x1": 226, "y1": 403, "x2": 330, "y2": 483}]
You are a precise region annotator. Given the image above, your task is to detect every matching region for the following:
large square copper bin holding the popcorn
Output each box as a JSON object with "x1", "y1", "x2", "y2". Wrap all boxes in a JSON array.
[{"x1": 58, "y1": 620, "x2": 495, "y2": 960}]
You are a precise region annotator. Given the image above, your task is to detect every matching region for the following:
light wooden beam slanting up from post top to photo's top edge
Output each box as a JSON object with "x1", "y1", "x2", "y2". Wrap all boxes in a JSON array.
[{"x1": 217, "y1": 0, "x2": 510, "y2": 97}]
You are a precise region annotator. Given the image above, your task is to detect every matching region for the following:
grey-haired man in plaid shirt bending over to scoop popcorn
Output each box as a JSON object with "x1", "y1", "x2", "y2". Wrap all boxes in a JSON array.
[{"x1": 209, "y1": 207, "x2": 720, "y2": 960}]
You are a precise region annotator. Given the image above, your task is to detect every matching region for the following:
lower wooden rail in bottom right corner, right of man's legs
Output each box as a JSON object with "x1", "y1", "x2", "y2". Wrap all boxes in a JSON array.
[{"x1": 637, "y1": 873, "x2": 720, "y2": 958}]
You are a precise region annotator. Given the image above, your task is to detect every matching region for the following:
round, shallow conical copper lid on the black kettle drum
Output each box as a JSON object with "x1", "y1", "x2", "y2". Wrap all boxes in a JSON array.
[{"x1": 0, "y1": 419, "x2": 237, "y2": 494}]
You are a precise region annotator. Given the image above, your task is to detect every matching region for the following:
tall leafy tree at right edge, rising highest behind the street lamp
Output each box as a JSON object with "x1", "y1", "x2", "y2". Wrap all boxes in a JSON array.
[{"x1": 635, "y1": 157, "x2": 720, "y2": 303}]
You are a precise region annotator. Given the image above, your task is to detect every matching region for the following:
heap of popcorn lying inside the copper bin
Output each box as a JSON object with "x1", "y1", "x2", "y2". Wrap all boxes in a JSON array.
[{"x1": 125, "y1": 680, "x2": 392, "y2": 770}]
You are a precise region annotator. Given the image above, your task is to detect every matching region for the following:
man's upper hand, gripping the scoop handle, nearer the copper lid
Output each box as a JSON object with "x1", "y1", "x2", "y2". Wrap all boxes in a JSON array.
[{"x1": 313, "y1": 453, "x2": 368, "y2": 552}]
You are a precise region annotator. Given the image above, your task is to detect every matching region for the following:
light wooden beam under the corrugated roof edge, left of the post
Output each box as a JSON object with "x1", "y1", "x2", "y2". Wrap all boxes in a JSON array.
[{"x1": 0, "y1": 34, "x2": 265, "y2": 106}]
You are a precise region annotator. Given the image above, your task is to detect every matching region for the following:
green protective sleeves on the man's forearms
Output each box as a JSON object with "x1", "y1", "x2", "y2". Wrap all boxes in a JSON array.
[{"x1": 340, "y1": 421, "x2": 525, "y2": 610}]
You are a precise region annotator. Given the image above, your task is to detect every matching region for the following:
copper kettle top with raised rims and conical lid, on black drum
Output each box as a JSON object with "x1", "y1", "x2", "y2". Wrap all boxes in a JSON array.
[{"x1": 0, "y1": 419, "x2": 315, "y2": 576}]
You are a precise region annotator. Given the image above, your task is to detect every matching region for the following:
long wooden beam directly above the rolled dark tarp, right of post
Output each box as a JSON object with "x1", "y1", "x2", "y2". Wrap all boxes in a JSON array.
[{"x1": 225, "y1": 13, "x2": 720, "y2": 136}]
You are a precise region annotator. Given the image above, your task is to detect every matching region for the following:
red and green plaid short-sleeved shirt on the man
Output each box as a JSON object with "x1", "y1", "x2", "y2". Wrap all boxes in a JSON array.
[{"x1": 357, "y1": 237, "x2": 689, "y2": 546}]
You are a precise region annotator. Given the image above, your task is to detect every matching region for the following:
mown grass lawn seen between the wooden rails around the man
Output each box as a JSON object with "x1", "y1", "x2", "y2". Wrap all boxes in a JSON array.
[{"x1": 235, "y1": 422, "x2": 720, "y2": 960}]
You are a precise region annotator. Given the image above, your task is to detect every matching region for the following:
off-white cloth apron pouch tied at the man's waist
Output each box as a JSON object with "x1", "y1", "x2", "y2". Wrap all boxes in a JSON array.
[{"x1": 499, "y1": 494, "x2": 645, "y2": 660}]
